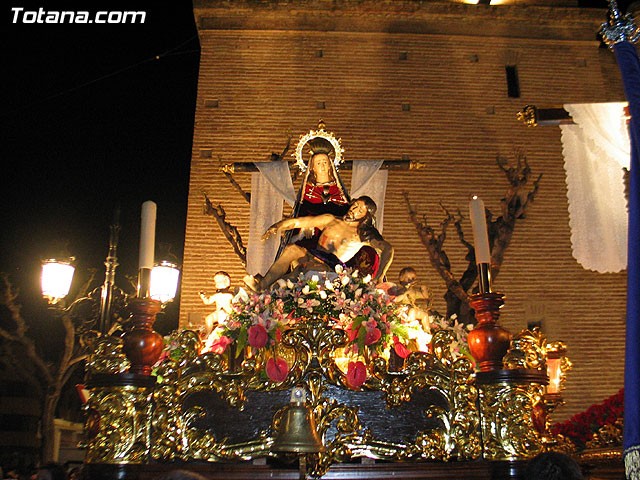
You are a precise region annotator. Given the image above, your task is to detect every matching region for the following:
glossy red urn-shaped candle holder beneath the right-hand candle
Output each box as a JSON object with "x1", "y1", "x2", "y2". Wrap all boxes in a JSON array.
[{"x1": 467, "y1": 292, "x2": 511, "y2": 372}]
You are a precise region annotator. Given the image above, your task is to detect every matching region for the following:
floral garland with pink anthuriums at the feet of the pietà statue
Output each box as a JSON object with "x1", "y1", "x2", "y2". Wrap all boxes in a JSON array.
[{"x1": 203, "y1": 266, "x2": 468, "y2": 388}]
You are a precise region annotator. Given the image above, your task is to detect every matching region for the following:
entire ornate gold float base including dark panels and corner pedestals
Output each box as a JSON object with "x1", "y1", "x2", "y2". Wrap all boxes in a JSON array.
[{"x1": 87, "y1": 318, "x2": 568, "y2": 478}]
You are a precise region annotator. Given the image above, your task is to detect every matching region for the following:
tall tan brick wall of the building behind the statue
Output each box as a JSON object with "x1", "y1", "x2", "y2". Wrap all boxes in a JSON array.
[{"x1": 181, "y1": 1, "x2": 626, "y2": 419}]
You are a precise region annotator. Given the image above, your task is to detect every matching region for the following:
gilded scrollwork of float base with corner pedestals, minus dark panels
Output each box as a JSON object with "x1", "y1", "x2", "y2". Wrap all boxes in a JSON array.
[{"x1": 87, "y1": 317, "x2": 558, "y2": 476}]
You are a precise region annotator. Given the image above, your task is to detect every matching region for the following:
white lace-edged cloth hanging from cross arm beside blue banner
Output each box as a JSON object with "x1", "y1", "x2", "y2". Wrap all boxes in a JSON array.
[{"x1": 560, "y1": 103, "x2": 630, "y2": 273}]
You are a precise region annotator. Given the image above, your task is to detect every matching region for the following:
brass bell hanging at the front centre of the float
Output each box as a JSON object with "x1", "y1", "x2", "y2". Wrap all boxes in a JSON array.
[{"x1": 271, "y1": 387, "x2": 324, "y2": 453}]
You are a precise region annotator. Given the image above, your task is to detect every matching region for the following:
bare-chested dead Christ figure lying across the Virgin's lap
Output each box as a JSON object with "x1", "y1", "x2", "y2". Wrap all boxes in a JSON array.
[{"x1": 244, "y1": 196, "x2": 393, "y2": 291}]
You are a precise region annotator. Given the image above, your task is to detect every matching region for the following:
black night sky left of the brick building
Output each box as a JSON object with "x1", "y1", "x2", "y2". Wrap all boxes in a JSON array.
[{"x1": 0, "y1": 0, "x2": 200, "y2": 330}]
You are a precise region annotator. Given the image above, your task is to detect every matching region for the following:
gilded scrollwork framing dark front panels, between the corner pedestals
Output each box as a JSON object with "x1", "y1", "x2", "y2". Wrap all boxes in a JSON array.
[{"x1": 146, "y1": 318, "x2": 481, "y2": 476}]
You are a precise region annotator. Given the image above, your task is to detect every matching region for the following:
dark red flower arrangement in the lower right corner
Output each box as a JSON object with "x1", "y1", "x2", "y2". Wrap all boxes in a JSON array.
[{"x1": 551, "y1": 389, "x2": 624, "y2": 449}]
